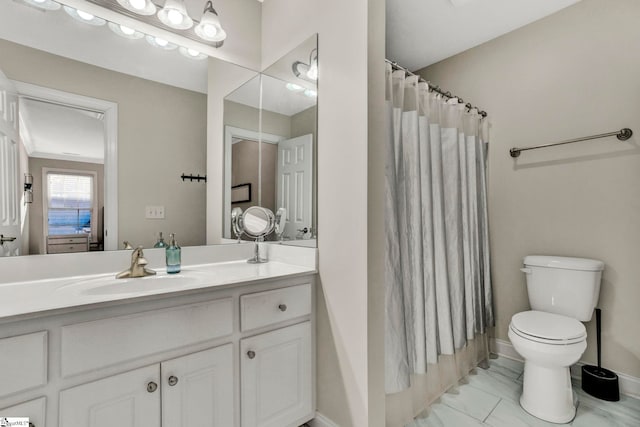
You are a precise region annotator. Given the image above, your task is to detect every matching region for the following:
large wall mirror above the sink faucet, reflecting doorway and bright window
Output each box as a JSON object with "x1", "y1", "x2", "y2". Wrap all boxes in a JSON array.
[{"x1": 0, "y1": 0, "x2": 260, "y2": 256}]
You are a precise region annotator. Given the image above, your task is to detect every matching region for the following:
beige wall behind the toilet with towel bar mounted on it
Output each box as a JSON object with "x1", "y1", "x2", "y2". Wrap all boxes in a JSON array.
[{"x1": 420, "y1": 0, "x2": 640, "y2": 377}]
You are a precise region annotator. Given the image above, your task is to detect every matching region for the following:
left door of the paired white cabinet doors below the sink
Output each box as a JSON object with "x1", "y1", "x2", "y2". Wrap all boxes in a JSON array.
[{"x1": 60, "y1": 365, "x2": 160, "y2": 427}]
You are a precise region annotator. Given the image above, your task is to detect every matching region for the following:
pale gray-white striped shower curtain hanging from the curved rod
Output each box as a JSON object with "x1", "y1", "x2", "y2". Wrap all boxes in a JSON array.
[{"x1": 385, "y1": 64, "x2": 493, "y2": 399}]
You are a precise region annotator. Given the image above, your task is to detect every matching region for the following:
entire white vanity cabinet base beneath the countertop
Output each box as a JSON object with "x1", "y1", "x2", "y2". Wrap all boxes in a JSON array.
[{"x1": 0, "y1": 273, "x2": 315, "y2": 427}]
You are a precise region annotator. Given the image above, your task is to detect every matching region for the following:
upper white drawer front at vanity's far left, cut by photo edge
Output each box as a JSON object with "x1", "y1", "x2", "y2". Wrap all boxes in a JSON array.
[{"x1": 0, "y1": 331, "x2": 47, "y2": 397}]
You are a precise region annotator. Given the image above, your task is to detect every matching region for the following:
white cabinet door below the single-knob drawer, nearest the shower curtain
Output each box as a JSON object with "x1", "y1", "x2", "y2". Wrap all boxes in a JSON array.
[{"x1": 240, "y1": 322, "x2": 313, "y2": 427}]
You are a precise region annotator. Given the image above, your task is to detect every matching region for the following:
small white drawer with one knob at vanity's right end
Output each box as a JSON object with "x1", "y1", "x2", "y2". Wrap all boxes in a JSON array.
[{"x1": 240, "y1": 283, "x2": 311, "y2": 331}]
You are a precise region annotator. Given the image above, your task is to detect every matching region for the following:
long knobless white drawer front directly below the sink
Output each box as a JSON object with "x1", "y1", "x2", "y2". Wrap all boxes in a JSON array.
[{"x1": 61, "y1": 298, "x2": 233, "y2": 377}]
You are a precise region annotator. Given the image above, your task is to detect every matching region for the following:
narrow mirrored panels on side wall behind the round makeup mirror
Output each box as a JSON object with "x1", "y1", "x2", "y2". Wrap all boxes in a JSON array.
[{"x1": 223, "y1": 35, "x2": 318, "y2": 246}]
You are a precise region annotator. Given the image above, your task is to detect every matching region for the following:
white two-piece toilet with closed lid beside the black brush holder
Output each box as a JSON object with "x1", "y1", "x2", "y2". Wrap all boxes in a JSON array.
[{"x1": 509, "y1": 256, "x2": 604, "y2": 423}]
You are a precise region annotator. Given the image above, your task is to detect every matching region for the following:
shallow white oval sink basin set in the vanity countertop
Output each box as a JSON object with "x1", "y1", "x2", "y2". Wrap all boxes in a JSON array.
[{"x1": 59, "y1": 273, "x2": 203, "y2": 295}]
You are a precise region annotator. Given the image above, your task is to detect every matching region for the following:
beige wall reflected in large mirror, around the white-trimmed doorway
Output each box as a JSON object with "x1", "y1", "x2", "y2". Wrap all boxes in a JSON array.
[{"x1": 0, "y1": 40, "x2": 207, "y2": 251}]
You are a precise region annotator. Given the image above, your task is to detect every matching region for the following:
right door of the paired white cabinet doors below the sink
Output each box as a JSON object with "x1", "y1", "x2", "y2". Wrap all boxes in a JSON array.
[{"x1": 161, "y1": 344, "x2": 234, "y2": 427}]
